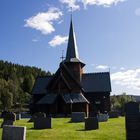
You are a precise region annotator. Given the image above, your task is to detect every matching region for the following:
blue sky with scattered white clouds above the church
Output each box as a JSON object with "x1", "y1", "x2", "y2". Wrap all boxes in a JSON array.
[{"x1": 0, "y1": 0, "x2": 140, "y2": 95}]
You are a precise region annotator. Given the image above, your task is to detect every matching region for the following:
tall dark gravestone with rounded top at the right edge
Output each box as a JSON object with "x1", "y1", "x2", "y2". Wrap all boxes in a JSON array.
[{"x1": 125, "y1": 102, "x2": 140, "y2": 140}]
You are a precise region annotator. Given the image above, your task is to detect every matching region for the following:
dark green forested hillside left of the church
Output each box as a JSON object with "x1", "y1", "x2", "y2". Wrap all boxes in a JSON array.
[{"x1": 0, "y1": 60, "x2": 51, "y2": 112}]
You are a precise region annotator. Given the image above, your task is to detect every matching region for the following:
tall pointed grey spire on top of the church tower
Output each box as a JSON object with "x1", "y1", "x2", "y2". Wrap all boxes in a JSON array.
[{"x1": 66, "y1": 17, "x2": 79, "y2": 61}]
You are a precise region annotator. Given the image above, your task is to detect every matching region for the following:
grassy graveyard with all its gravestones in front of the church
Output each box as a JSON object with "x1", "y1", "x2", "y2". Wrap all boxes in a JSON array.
[{"x1": 0, "y1": 101, "x2": 140, "y2": 140}]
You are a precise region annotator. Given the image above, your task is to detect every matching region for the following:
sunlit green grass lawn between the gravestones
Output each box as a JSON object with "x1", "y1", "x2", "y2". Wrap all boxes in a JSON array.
[{"x1": 0, "y1": 117, "x2": 125, "y2": 140}]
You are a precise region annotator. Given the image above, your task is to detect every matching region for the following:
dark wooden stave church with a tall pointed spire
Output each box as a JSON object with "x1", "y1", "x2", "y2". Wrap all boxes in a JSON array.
[{"x1": 30, "y1": 19, "x2": 111, "y2": 116}]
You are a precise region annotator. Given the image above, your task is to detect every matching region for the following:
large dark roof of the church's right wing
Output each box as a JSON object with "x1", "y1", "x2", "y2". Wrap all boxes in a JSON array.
[{"x1": 81, "y1": 72, "x2": 111, "y2": 93}]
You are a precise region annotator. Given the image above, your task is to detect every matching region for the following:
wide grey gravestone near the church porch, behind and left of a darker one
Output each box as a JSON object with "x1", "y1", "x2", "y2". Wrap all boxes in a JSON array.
[{"x1": 71, "y1": 112, "x2": 86, "y2": 122}]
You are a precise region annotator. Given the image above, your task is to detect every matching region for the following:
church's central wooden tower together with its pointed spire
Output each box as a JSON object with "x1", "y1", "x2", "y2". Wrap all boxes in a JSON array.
[{"x1": 60, "y1": 18, "x2": 85, "y2": 93}]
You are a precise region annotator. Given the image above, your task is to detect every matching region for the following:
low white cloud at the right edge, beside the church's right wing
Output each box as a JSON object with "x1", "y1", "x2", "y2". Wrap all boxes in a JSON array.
[{"x1": 111, "y1": 68, "x2": 140, "y2": 90}]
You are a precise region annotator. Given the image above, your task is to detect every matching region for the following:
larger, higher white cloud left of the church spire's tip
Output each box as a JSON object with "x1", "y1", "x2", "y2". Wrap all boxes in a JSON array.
[{"x1": 24, "y1": 8, "x2": 63, "y2": 34}]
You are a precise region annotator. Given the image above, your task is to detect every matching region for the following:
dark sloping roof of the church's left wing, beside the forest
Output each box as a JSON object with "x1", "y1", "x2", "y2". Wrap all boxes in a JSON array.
[{"x1": 32, "y1": 76, "x2": 53, "y2": 94}]
